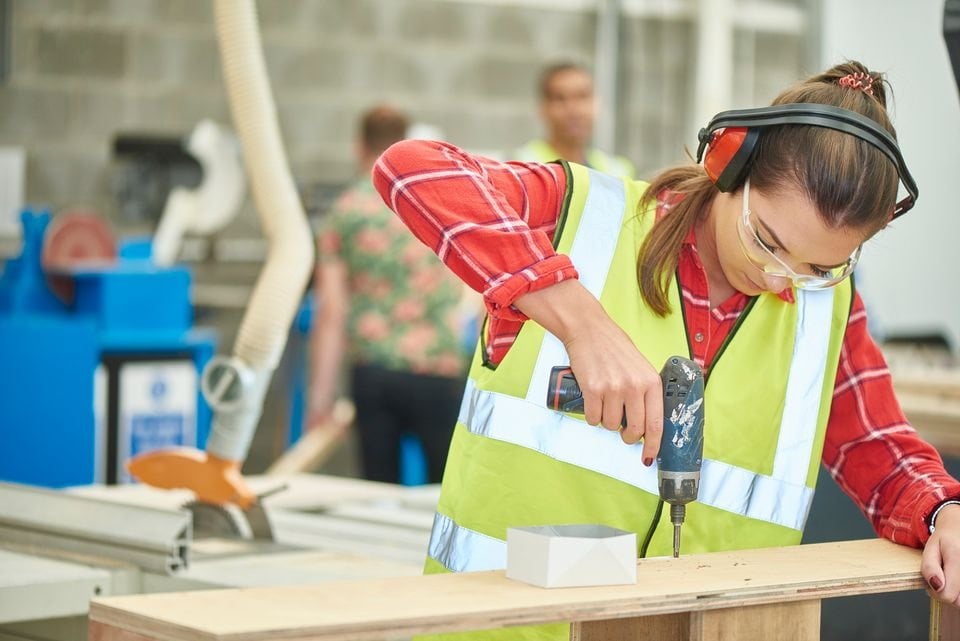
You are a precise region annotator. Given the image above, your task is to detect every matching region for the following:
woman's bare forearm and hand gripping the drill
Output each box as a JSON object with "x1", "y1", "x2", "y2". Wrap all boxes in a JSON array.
[{"x1": 515, "y1": 280, "x2": 663, "y2": 465}]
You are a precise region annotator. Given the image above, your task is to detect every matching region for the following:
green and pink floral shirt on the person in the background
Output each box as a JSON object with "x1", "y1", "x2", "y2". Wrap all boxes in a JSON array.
[{"x1": 319, "y1": 177, "x2": 467, "y2": 376}]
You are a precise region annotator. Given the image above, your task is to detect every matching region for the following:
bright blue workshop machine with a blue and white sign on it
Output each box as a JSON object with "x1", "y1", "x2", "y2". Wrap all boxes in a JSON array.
[{"x1": 0, "y1": 211, "x2": 216, "y2": 487}]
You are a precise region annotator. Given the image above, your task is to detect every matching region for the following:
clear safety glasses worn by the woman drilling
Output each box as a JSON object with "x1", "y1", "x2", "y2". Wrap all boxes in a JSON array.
[{"x1": 737, "y1": 178, "x2": 863, "y2": 289}]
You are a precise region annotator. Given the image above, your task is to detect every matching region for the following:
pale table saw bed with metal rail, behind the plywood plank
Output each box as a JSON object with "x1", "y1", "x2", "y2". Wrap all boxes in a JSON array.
[{"x1": 0, "y1": 475, "x2": 439, "y2": 641}]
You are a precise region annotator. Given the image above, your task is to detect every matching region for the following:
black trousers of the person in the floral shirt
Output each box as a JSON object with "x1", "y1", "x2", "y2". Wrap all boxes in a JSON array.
[{"x1": 351, "y1": 365, "x2": 466, "y2": 483}]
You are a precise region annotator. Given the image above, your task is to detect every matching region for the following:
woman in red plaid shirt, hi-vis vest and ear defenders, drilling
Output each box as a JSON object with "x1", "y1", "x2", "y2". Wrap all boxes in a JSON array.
[{"x1": 374, "y1": 62, "x2": 960, "y2": 638}]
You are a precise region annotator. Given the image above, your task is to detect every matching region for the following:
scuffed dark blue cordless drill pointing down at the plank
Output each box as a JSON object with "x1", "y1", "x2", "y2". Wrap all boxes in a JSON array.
[{"x1": 547, "y1": 356, "x2": 704, "y2": 558}]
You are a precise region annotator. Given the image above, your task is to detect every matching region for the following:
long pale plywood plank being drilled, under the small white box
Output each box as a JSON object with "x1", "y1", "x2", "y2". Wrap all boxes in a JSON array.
[{"x1": 90, "y1": 539, "x2": 924, "y2": 641}]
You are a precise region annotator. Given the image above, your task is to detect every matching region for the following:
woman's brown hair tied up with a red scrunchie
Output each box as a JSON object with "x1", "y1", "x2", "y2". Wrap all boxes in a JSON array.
[{"x1": 637, "y1": 61, "x2": 898, "y2": 316}]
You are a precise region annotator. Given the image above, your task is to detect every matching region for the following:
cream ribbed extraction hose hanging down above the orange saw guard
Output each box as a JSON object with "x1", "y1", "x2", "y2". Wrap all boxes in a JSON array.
[{"x1": 207, "y1": 0, "x2": 314, "y2": 460}]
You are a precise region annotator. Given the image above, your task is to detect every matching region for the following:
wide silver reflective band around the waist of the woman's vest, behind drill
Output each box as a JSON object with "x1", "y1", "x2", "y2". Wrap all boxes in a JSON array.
[{"x1": 460, "y1": 380, "x2": 813, "y2": 530}]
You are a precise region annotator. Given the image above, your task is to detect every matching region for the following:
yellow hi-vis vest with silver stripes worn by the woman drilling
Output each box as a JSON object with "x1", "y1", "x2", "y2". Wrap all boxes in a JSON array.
[{"x1": 426, "y1": 164, "x2": 853, "y2": 638}]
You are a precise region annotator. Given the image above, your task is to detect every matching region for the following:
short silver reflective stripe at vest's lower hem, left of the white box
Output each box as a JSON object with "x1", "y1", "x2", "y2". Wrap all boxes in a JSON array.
[{"x1": 427, "y1": 512, "x2": 507, "y2": 572}]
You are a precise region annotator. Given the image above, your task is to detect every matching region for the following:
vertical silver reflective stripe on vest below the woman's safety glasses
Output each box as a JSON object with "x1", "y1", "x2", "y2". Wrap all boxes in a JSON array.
[{"x1": 773, "y1": 289, "x2": 834, "y2": 485}]
